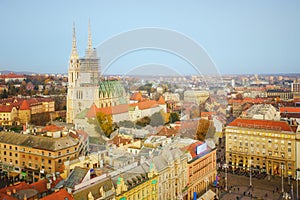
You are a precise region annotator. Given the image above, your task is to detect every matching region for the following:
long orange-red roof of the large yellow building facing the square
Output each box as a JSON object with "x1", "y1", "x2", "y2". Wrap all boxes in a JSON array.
[{"x1": 228, "y1": 118, "x2": 294, "y2": 132}]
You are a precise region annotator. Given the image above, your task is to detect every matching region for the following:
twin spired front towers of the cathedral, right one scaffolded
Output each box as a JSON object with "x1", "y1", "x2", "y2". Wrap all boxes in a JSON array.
[{"x1": 67, "y1": 22, "x2": 100, "y2": 123}]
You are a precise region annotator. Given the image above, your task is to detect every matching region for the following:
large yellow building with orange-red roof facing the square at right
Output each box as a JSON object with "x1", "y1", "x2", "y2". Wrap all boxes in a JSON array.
[{"x1": 225, "y1": 118, "x2": 299, "y2": 177}]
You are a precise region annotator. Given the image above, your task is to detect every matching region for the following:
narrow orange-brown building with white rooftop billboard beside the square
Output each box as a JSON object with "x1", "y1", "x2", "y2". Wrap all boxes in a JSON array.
[{"x1": 182, "y1": 141, "x2": 217, "y2": 199}]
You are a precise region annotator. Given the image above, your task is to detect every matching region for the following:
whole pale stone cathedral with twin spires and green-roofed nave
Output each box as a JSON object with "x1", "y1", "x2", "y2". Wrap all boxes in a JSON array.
[{"x1": 66, "y1": 23, "x2": 128, "y2": 123}]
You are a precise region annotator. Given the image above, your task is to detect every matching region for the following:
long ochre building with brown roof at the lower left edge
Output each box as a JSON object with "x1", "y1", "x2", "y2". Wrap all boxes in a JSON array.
[{"x1": 0, "y1": 132, "x2": 80, "y2": 182}]
